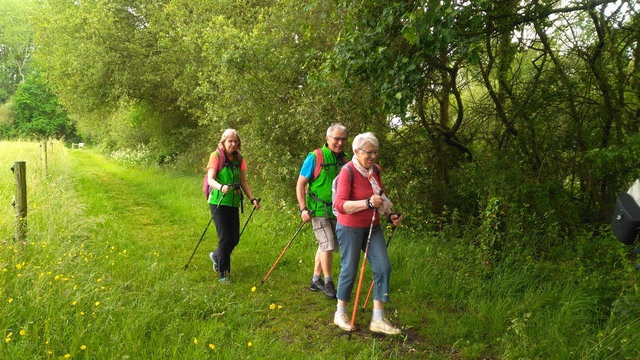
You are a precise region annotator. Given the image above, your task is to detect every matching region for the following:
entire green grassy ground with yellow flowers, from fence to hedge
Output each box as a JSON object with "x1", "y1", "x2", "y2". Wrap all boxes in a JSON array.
[{"x1": 0, "y1": 142, "x2": 640, "y2": 359}]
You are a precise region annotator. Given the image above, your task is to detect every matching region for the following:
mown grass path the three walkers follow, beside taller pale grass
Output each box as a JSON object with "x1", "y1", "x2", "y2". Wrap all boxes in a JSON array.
[{"x1": 63, "y1": 151, "x2": 415, "y2": 358}]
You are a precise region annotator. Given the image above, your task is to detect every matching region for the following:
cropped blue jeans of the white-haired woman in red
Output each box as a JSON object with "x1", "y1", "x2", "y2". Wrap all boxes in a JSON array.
[{"x1": 336, "y1": 223, "x2": 391, "y2": 303}]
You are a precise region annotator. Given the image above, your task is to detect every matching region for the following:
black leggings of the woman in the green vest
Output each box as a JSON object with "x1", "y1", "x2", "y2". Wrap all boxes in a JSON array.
[{"x1": 209, "y1": 204, "x2": 240, "y2": 278}]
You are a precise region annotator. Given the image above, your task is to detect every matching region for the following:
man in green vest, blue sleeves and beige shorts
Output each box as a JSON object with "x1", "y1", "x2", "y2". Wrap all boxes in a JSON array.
[{"x1": 296, "y1": 123, "x2": 348, "y2": 299}]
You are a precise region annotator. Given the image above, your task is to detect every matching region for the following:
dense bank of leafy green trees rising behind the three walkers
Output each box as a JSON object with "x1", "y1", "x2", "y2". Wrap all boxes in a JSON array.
[{"x1": 28, "y1": 0, "x2": 640, "y2": 258}]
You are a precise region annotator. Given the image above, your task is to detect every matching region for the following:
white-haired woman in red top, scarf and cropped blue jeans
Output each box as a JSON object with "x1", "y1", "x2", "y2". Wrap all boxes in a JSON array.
[{"x1": 333, "y1": 132, "x2": 402, "y2": 335}]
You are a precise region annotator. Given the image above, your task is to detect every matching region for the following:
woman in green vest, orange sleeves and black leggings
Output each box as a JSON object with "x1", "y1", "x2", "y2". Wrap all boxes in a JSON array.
[{"x1": 207, "y1": 129, "x2": 260, "y2": 283}]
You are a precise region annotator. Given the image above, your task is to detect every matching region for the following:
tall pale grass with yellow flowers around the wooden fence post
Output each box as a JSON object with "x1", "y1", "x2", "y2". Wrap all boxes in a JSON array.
[{"x1": 0, "y1": 141, "x2": 94, "y2": 358}]
